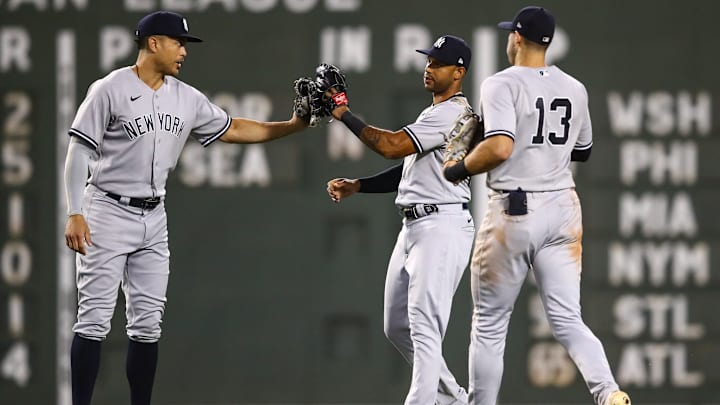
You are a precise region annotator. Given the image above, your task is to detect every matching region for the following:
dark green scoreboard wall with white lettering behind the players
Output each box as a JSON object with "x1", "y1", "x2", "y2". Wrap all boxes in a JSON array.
[{"x1": 0, "y1": 0, "x2": 720, "y2": 405}]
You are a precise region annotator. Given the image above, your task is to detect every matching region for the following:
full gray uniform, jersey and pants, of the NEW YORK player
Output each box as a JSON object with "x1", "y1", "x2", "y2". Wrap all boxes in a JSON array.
[{"x1": 69, "y1": 67, "x2": 231, "y2": 342}]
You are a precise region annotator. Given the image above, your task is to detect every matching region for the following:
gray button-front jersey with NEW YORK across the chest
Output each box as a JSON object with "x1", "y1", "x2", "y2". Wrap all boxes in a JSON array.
[{"x1": 70, "y1": 67, "x2": 231, "y2": 197}]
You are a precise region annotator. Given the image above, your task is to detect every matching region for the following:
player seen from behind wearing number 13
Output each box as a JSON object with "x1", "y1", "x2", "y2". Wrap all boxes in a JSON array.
[{"x1": 445, "y1": 7, "x2": 630, "y2": 405}]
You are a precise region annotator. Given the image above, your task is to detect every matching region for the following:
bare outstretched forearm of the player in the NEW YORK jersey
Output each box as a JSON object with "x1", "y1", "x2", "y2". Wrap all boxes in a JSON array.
[{"x1": 220, "y1": 113, "x2": 308, "y2": 143}]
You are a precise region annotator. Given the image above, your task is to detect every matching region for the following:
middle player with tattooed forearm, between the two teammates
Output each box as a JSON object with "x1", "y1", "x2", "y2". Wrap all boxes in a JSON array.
[{"x1": 327, "y1": 35, "x2": 475, "y2": 405}]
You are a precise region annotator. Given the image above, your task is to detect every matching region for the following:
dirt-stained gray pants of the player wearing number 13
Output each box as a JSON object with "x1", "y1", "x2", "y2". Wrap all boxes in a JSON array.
[{"x1": 469, "y1": 189, "x2": 618, "y2": 405}]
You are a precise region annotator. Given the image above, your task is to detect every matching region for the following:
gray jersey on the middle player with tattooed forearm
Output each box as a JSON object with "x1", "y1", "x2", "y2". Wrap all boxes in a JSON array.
[{"x1": 395, "y1": 94, "x2": 470, "y2": 207}]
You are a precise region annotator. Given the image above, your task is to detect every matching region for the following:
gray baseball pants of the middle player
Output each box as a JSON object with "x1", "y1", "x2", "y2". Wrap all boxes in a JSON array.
[{"x1": 384, "y1": 204, "x2": 475, "y2": 405}]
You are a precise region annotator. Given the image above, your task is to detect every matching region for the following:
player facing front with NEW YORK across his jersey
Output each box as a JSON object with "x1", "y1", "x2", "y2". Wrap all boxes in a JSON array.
[{"x1": 65, "y1": 11, "x2": 307, "y2": 405}]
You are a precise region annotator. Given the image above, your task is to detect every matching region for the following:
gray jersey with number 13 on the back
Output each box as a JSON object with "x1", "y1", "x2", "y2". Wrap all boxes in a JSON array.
[{"x1": 481, "y1": 66, "x2": 592, "y2": 191}]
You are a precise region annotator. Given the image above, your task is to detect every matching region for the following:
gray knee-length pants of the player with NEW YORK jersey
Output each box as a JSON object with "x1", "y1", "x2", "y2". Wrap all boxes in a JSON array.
[{"x1": 73, "y1": 185, "x2": 170, "y2": 343}]
